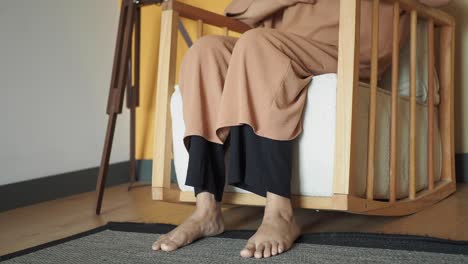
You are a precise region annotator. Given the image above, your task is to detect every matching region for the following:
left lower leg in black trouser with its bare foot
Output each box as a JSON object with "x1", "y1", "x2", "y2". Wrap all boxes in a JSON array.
[{"x1": 153, "y1": 136, "x2": 225, "y2": 251}]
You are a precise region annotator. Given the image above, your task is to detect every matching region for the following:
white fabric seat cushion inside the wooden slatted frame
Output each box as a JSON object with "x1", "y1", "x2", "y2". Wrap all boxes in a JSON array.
[{"x1": 171, "y1": 74, "x2": 442, "y2": 199}]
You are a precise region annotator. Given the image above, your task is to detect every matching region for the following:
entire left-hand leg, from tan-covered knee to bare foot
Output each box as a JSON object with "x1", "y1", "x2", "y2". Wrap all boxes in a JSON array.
[{"x1": 153, "y1": 35, "x2": 237, "y2": 251}]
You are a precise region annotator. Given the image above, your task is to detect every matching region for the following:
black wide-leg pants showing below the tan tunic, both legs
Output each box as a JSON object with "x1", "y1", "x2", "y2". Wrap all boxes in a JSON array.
[{"x1": 185, "y1": 124, "x2": 292, "y2": 202}]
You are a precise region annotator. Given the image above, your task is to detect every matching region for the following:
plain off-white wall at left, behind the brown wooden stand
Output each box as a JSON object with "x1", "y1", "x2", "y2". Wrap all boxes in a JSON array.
[{"x1": 0, "y1": 0, "x2": 129, "y2": 185}]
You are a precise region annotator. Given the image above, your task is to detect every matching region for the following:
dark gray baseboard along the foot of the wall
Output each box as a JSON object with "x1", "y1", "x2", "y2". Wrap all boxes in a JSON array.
[{"x1": 0, "y1": 153, "x2": 468, "y2": 212}]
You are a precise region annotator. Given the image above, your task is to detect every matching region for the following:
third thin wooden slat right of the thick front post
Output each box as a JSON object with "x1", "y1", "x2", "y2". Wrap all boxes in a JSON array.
[{"x1": 409, "y1": 10, "x2": 418, "y2": 199}]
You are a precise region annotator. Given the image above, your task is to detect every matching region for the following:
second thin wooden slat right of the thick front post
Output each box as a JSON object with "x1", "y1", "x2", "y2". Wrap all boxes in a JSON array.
[{"x1": 389, "y1": 1, "x2": 400, "y2": 202}]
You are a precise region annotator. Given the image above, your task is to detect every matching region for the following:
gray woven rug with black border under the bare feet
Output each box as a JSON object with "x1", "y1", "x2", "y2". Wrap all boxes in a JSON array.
[{"x1": 0, "y1": 222, "x2": 468, "y2": 264}]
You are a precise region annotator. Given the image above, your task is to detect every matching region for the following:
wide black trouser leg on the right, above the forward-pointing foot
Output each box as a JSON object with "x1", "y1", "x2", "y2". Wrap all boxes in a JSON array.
[{"x1": 227, "y1": 124, "x2": 293, "y2": 198}]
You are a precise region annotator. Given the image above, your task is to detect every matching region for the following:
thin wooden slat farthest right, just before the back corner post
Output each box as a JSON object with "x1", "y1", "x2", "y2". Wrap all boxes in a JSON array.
[{"x1": 427, "y1": 19, "x2": 434, "y2": 190}]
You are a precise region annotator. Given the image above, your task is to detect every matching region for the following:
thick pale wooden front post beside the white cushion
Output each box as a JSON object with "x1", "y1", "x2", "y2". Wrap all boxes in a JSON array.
[{"x1": 333, "y1": 0, "x2": 361, "y2": 194}]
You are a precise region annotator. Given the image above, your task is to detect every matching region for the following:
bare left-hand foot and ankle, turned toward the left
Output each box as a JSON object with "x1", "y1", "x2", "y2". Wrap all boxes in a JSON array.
[{"x1": 152, "y1": 192, "x2": 224, "y2": 251}]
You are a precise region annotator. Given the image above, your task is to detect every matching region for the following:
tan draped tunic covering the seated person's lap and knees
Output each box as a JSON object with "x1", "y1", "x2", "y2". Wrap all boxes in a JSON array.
[{"x1": 179, "y1": 0, "x2": 408, "y2": 152}]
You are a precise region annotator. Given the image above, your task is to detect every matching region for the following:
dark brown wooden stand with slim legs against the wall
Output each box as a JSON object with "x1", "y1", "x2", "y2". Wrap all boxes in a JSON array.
[{"x1": 96, "y1": 0, "x2": 163, "y2": 215}]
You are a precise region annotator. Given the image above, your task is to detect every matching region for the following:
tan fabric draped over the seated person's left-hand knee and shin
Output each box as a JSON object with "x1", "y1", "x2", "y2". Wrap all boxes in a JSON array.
[{"x1": 179, "y1": 35, "x2": 238, "y2": 151}]
